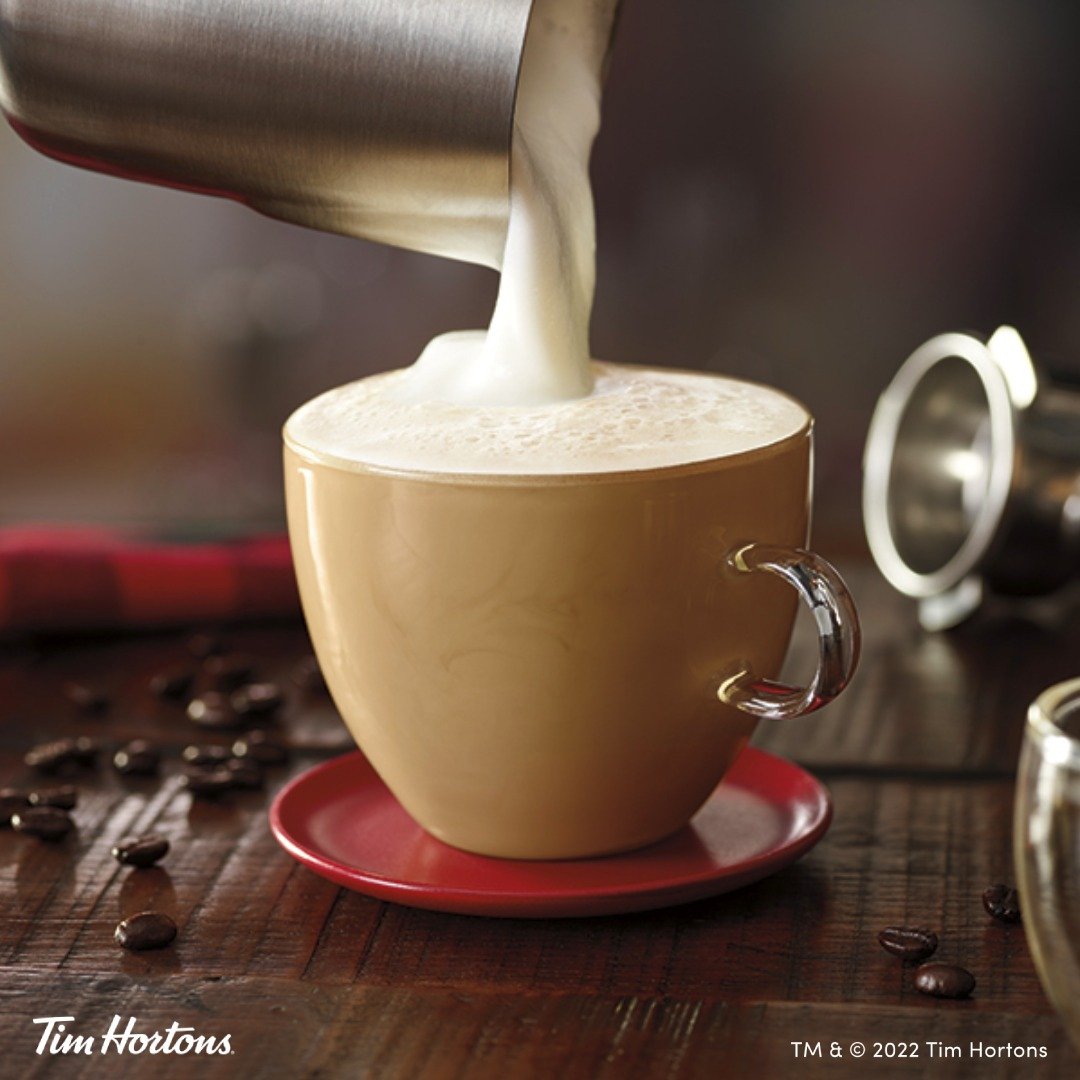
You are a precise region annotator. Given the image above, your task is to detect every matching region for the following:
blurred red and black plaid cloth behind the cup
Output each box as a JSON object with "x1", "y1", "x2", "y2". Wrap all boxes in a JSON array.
[{"x1": 0, "y1": 527, "x2": 300, "y2": 632}]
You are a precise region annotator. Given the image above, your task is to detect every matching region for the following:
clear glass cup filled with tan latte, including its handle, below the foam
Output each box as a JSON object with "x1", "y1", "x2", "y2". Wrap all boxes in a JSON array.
[{"x1": 285, "y1": 380, "x2": 859, "y2": 859}]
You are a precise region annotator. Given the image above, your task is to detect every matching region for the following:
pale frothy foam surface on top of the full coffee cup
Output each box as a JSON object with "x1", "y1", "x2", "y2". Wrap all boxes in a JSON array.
[{"x1": 285, "y1": 363, "x2": 810, "y2": 475}]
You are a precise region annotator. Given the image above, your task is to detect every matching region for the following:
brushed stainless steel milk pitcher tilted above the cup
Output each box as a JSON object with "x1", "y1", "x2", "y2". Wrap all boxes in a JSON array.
[{"x1": 0, "y1": 0, "x2": 578, "y2": 266}]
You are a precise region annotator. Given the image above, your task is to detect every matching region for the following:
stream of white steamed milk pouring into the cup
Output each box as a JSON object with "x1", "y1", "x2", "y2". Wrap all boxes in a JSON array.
[{"x1": 397, "y1": 0, "x2": 616, "y2": 405}]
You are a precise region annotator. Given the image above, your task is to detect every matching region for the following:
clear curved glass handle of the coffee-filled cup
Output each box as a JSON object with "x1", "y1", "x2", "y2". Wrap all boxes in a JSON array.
[{"x1": 717, "y1": 543, "x2": 861, "y2": 720}]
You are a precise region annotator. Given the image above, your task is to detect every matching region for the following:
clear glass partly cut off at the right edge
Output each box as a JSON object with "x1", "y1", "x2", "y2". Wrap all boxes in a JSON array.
[{"x1": 1013, "y1": 678, "x2": 1080, "y2": 1050}]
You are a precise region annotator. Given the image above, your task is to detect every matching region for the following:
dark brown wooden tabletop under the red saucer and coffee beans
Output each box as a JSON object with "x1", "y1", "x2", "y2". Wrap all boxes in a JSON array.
[{"x1": 0, "y1": 564, "x2": 1080, "y2": 1080}]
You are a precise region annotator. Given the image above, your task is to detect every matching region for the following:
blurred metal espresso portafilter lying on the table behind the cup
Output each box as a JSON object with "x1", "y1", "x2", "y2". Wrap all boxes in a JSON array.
[{"x1": 863, "y1": 326, "x2": 1080, "y2": 630}]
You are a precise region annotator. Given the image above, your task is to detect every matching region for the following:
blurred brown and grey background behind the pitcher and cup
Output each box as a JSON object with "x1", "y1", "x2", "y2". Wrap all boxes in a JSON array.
[{"x1": 0, "y1": 0, "x2": 1080, "y2": 554}]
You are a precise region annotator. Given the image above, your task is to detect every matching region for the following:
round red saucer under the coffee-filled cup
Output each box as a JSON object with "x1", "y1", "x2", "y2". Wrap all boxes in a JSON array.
[{"x1": 270, "y1": 747, "x2": 833, "y2": 918}]
